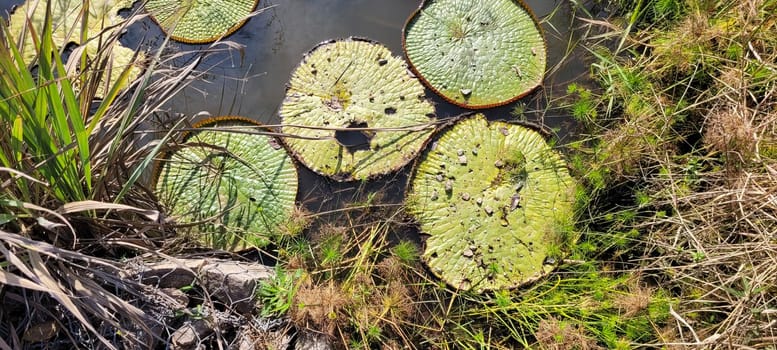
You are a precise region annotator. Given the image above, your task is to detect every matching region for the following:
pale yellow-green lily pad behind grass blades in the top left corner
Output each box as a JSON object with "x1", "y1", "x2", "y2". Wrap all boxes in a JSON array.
[{"x1": 8, "y1": 0, "x2": 144, "y2": 98}]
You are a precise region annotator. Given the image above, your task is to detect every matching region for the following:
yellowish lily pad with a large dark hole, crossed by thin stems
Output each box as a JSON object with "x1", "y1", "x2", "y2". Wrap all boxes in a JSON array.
[{"x1": 280, "y1": 38, "x2": 434, "y2": 180}]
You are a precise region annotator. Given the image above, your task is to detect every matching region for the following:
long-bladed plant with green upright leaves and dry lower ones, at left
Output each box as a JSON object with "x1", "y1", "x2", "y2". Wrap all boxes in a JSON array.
[{"x1": 0, "y1": 1, "x2": 206, "y2": 349}]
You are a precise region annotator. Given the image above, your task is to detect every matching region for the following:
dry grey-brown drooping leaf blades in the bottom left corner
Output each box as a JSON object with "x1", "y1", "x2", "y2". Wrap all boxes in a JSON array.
[{"x1": 0, "y1": 231, "x2": 158, "y2": 349}]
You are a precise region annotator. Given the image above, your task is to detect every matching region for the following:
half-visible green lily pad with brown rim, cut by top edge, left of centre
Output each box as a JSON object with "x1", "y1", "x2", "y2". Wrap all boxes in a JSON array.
[{"x1": 146, "y1": 0, "x2": 259, "y2": 44}]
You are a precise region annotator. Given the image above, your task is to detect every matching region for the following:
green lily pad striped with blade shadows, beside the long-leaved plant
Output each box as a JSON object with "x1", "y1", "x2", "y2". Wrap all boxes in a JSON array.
[{"x1": 156, "y1": 117, "x2": 297, "y2": 251}]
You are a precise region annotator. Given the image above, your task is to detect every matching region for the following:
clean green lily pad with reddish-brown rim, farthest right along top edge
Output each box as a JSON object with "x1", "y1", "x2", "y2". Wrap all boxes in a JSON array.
[{"x1": 403, "y1": 0, "x2": 546, "y2": 108}]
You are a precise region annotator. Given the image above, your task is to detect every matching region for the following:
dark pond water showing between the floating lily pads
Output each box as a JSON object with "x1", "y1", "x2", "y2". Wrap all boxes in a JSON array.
[{"x1": 0, "y1": 0, "x2": 593, "y2": 219}]
